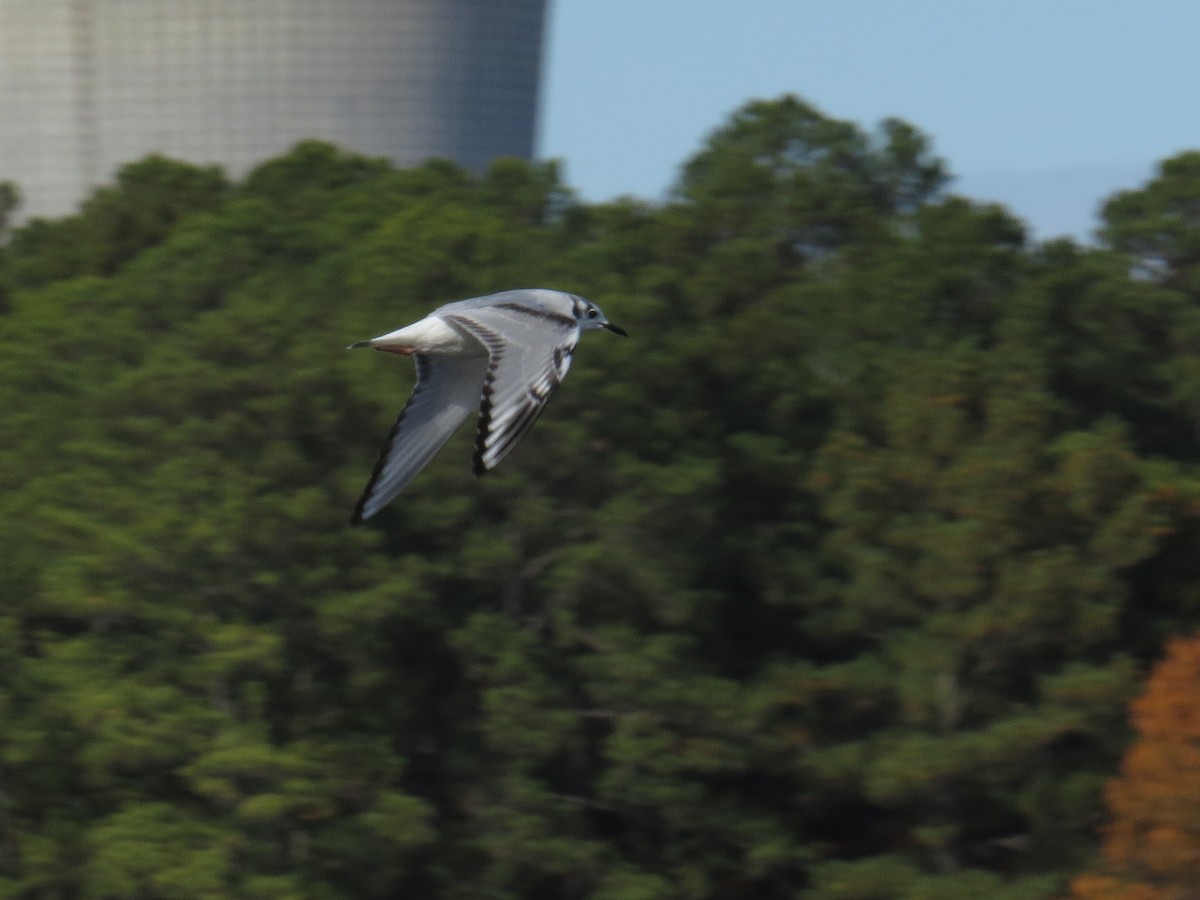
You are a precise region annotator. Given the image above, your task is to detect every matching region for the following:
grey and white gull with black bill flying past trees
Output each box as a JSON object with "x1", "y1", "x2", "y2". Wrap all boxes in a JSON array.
[{"x1": 350, "y1": 289, "x2": 625, "y2": 524}]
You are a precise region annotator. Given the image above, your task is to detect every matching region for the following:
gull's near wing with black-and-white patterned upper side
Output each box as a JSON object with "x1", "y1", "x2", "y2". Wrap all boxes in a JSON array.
[{"x1": 445, "y1": 302, "x2": 580, "y2": 475}]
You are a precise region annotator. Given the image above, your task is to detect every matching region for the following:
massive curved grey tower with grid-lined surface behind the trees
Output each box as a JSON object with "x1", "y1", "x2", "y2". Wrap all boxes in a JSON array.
[{"x1": 0, "y1": 0, "x2": 546, "y2": 216}]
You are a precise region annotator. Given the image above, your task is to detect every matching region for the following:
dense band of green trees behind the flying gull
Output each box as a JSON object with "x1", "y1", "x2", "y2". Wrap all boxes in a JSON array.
[{"x1": 0, "y1": 97, "x2": 1200, "y2": 900}]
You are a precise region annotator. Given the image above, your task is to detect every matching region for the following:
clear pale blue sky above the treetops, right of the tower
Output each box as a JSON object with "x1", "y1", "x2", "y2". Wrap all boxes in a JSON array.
[{"x1": 539, "y1": 0, "x2": 1200, "y2": 238}]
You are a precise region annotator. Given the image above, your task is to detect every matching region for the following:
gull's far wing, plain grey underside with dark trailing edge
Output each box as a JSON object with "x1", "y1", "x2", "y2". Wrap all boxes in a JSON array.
[{"x1": 350, "y1": 353, "x2": 488, "y2": 524}]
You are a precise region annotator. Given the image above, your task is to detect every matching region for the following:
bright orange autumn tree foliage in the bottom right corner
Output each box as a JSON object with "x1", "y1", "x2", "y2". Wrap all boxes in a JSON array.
[{"x1": 1072, "y1": 638, "x2": 1200, "y2": 900}]
